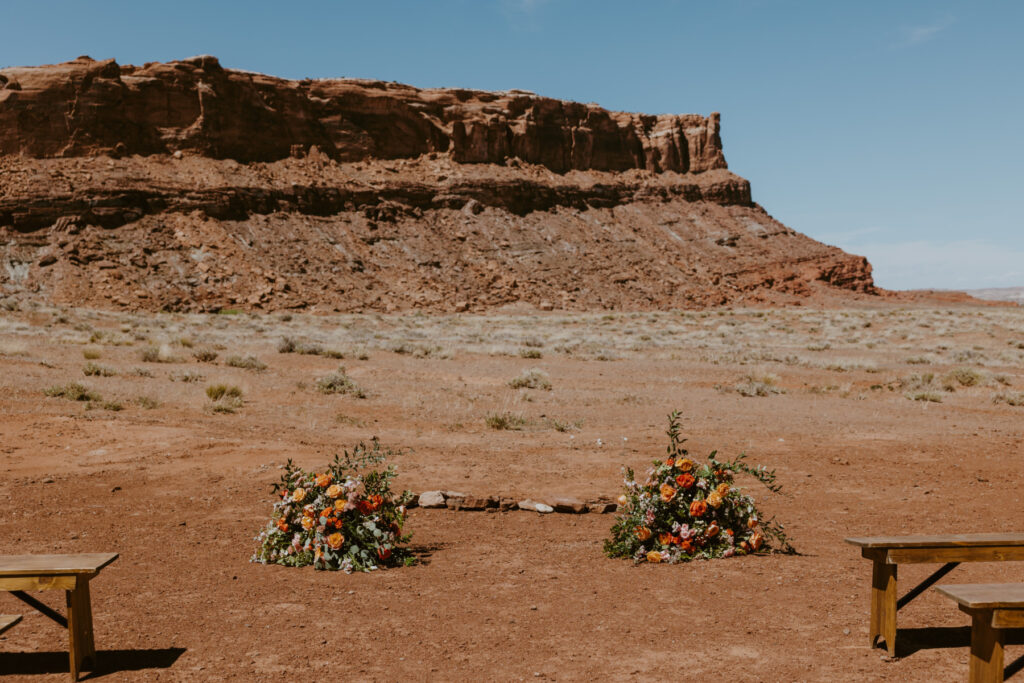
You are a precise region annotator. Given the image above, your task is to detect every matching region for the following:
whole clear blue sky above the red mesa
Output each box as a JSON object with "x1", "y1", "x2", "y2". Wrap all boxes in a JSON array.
[{"x1": 0, "y1": 0, "x2": 1024, "y2": 289}]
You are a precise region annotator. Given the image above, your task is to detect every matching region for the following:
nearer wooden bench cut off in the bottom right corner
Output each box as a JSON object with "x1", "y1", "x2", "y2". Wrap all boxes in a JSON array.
[{"x1": 935, "y1": 584, "x2": 1024, "y2": 683}]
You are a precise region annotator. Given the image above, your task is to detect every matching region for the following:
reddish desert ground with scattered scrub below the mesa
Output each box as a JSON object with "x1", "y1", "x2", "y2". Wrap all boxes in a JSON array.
[{"x1": 0, "y1": 304, "x2": 1024, "y2": 681}]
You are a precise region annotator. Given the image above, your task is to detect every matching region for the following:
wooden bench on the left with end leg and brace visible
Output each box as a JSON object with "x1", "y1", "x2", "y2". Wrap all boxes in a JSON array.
[{"x1": 0, "y1": 553, "x2": 118, "y2": 681}]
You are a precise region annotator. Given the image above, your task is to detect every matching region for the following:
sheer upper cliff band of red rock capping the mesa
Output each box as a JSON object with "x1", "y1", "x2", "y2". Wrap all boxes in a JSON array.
[{"x1": 0, "y1": 56, "x2": 726, "y2": 173}]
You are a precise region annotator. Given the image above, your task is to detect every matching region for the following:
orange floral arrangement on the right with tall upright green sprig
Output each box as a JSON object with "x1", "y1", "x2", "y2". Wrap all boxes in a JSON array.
[{"x1": 604, "y1": 412, "x2": 796, "y2": 563}]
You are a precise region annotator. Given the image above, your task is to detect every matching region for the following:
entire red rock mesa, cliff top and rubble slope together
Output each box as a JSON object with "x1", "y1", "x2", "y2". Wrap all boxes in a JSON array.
[{"x1": 0, "y1": 56, "x2": 874, "y2": 310}]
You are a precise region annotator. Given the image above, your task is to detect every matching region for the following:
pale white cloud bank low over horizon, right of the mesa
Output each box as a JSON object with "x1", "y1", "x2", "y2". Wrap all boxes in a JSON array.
[{"x1": 838, "y1": 240, "x2": 1024, "y2": 290}]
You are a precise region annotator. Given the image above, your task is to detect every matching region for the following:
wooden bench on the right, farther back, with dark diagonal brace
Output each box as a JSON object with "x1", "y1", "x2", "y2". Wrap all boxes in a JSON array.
[{"x1": 846, "y1": 533, "x2": 1024, "y2": 656}]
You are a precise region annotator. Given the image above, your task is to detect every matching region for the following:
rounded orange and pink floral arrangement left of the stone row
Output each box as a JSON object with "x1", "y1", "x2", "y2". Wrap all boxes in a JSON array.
[{"x1": 252, "y1": 438, "x2": 415, "y2": 572}]
